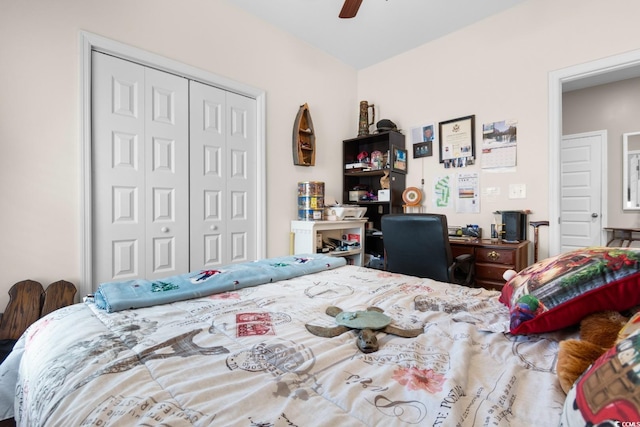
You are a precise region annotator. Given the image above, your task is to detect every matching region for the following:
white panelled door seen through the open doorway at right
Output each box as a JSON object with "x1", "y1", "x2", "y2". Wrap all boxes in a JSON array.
[{"x1": 560, "y1": 131, "x2": 606, "y2": 253}]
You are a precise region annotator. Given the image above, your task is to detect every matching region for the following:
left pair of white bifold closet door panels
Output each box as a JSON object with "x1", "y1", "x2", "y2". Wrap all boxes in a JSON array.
[{"x1": 92, "y1": 52, "x2": 189, "y2": 283}]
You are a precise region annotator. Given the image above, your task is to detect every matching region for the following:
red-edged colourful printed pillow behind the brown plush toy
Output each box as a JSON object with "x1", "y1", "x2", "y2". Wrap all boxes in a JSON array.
[{"x1": 500, "y1": 247, "x2": 640, "y2": 334}]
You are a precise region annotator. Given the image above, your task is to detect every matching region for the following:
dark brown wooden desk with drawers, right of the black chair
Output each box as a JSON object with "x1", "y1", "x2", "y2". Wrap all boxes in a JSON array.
[{"x1": 450, "y1": 239, "x2": 530, "y2": 291}]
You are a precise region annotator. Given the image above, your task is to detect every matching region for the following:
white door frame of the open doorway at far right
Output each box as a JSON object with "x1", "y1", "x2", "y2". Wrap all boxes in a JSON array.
[{"x1": 549, "y1": 50, "x2": 640, "y2": 256}]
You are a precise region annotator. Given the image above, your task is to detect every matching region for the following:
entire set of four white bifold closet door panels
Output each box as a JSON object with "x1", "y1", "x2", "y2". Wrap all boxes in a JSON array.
[{"x1": 92, "y1": 52, "x2": 256, "y2": 287}]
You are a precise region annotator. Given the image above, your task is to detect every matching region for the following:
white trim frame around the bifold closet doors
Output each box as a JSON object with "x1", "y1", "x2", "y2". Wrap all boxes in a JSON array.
[{"x1": 78, "y1": 31, "x2": 267, "y2": 296}]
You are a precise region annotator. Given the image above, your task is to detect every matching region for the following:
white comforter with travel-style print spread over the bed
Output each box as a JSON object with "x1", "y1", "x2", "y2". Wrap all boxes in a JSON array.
[{"x1": 0, "y1": 249, "x2": 636, "y2": 427}]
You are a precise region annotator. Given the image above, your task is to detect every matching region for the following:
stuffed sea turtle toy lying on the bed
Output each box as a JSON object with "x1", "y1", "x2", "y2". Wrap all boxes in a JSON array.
[{"x1": 305, "y1": 306, "x2": 423, "y2": 353}]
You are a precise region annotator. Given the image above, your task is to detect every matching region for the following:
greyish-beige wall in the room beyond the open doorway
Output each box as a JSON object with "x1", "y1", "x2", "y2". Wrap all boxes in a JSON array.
[{"x1": 562, "y1": 78, "x2": 640, "y2": 228}]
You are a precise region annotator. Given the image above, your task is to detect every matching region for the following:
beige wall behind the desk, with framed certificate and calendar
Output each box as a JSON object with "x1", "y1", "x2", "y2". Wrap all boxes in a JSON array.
[{"x1": 358, "y1": 0, "x2": 640, "y2": 256}]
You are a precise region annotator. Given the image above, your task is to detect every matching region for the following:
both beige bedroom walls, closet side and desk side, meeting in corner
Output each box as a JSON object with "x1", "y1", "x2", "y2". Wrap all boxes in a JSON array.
[{"x1": 0, "y1": 0, "x2": 640, "y2": 307}]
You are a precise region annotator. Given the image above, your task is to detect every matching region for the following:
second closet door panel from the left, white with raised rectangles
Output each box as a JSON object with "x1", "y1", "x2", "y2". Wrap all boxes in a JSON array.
[{"x1": 145, "y1": 68, "x2": 189, "y2": 279}]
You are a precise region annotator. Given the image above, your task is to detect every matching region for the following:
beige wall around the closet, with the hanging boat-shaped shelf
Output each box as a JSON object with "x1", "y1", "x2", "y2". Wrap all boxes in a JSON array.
[{"x1": 0, "y1": 0, "x2": 358, "y2": 311}]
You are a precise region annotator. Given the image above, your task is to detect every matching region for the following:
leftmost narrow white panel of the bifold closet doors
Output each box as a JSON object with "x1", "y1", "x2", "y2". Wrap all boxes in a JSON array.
[{"x1": 92, "y1": 52, "x2": 146, "y2": 286}]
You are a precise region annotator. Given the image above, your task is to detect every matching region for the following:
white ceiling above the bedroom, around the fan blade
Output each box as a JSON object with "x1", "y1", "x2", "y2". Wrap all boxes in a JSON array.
[{"x1": 227, "y1": 0, "x2": 525, "y2": 70}]
